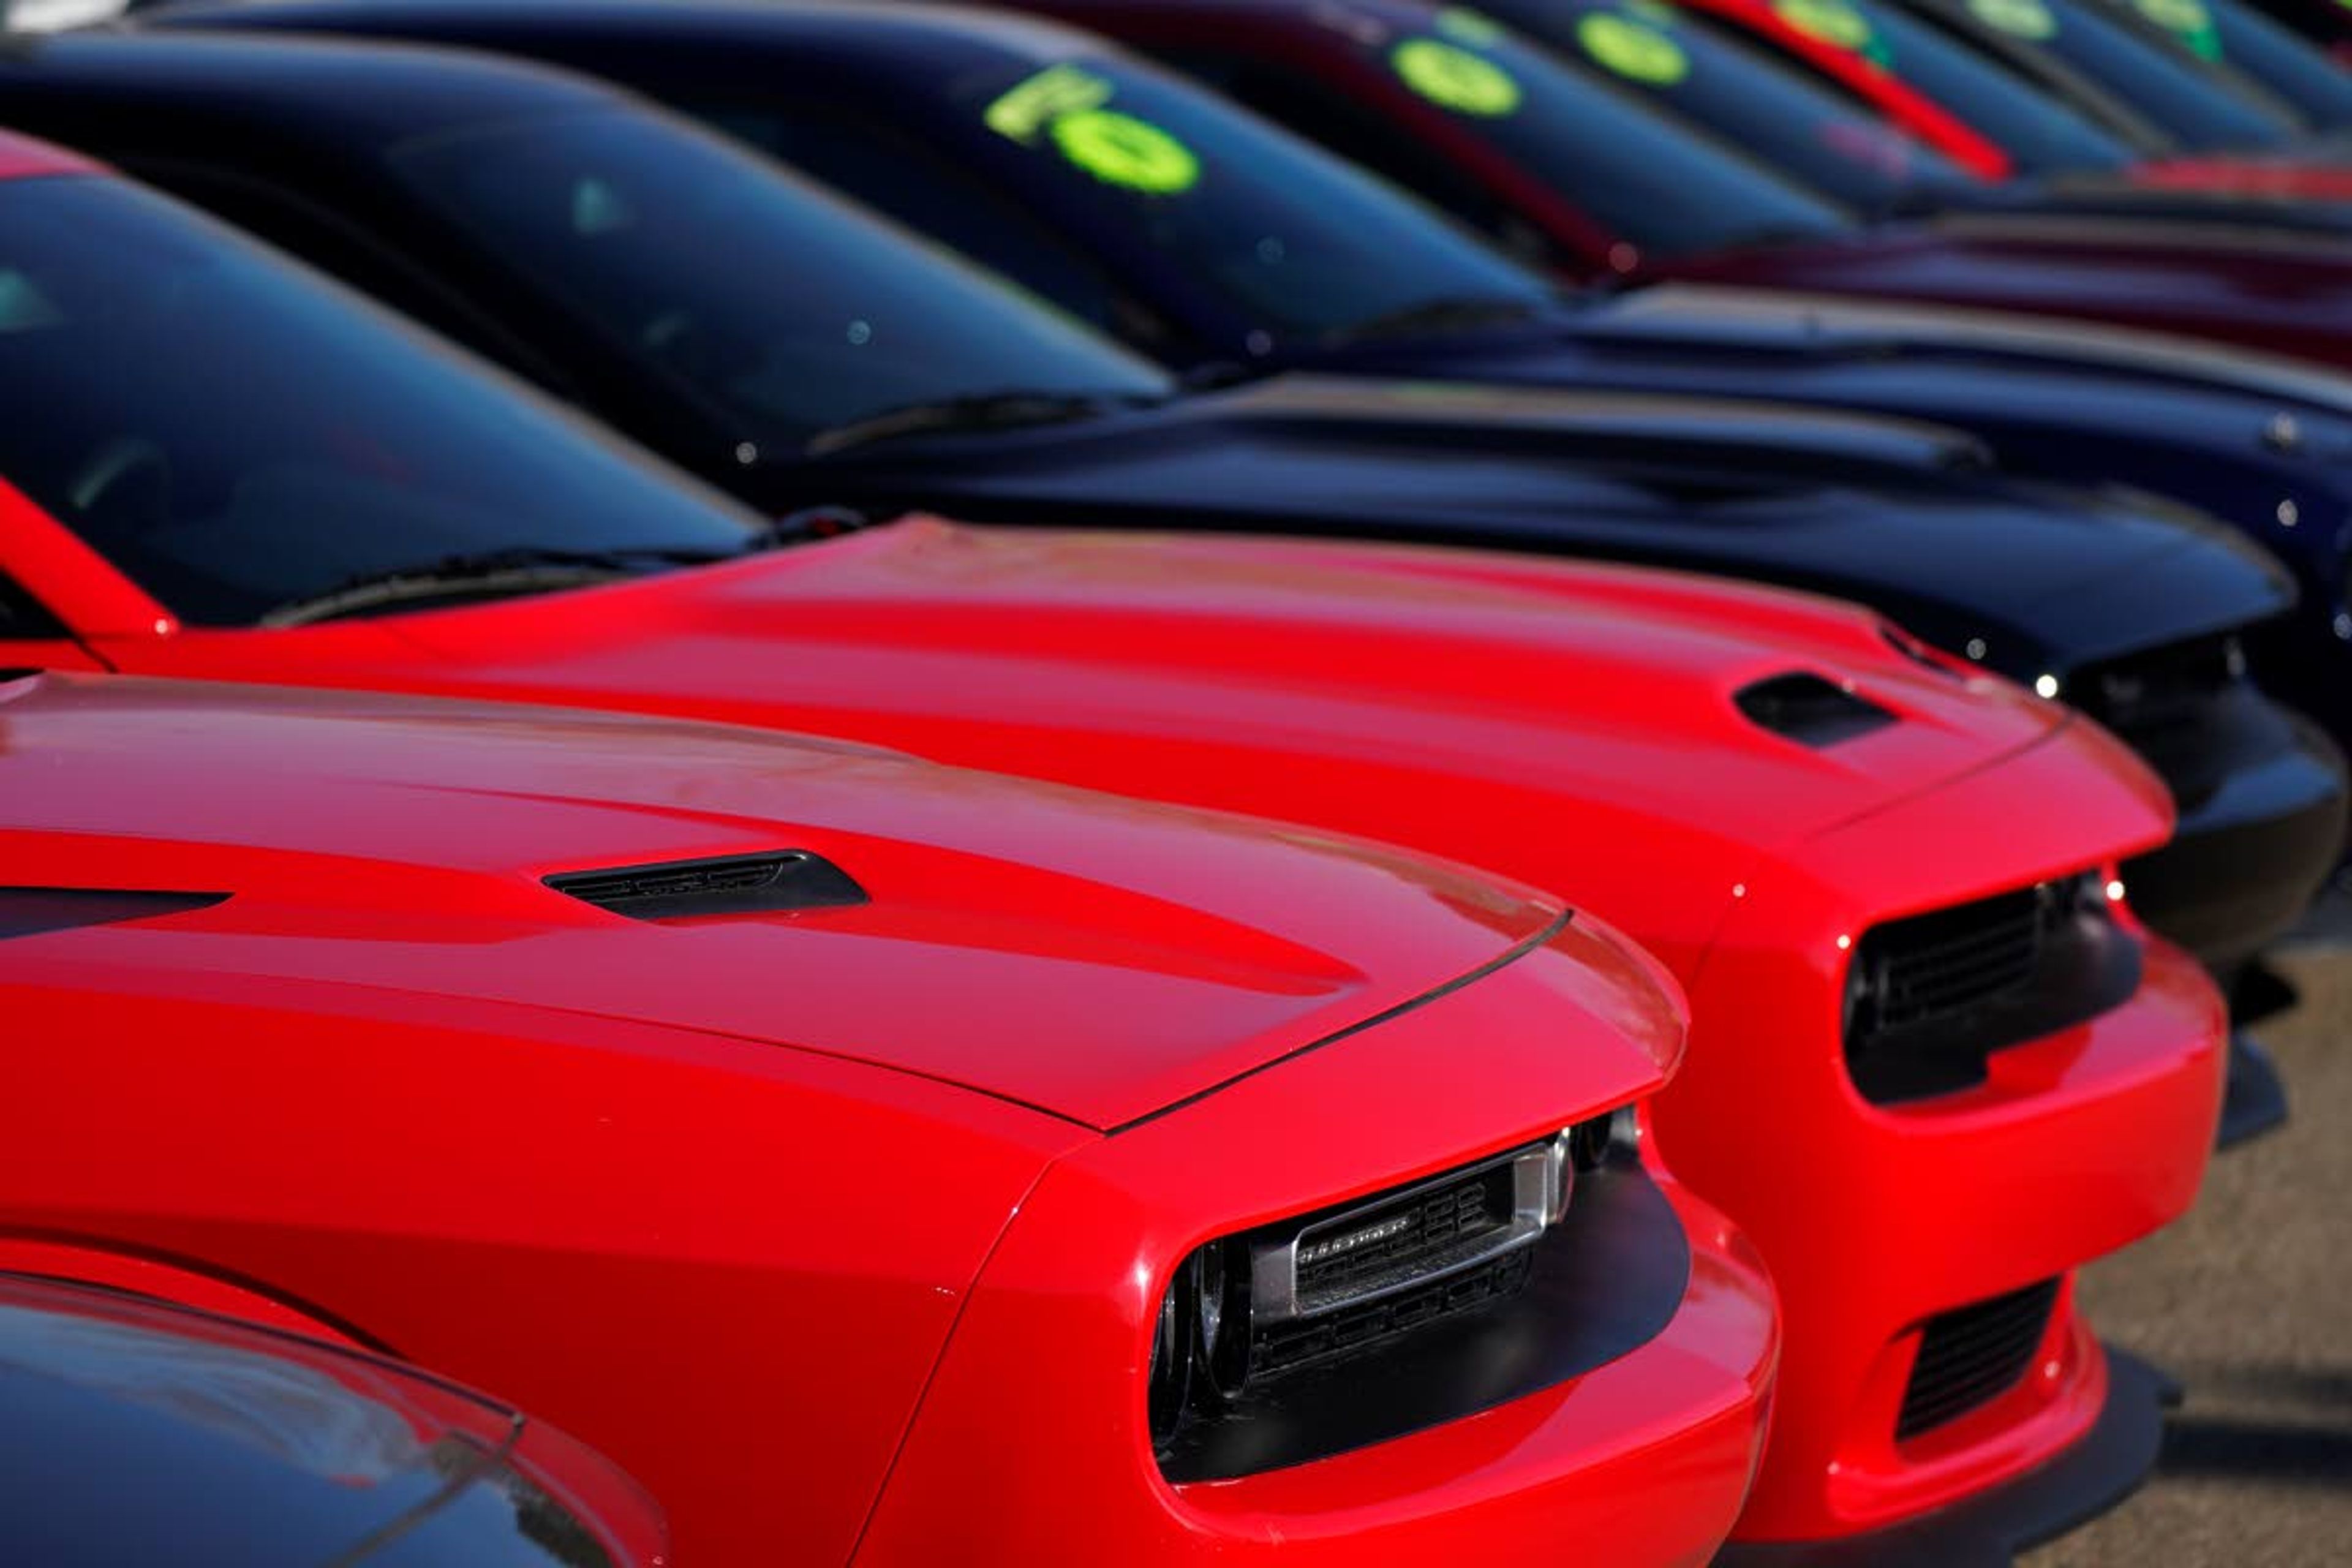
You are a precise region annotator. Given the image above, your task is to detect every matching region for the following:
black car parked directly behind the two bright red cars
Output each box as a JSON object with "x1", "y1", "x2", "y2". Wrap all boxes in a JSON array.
[{"x1": 13, "y1": 18, "x2": 2345, "y2": 1133}]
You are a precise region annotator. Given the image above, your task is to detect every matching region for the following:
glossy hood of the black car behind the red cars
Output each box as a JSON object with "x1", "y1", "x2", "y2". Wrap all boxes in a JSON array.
[{"x1": 794, "y1": 376, "x2": 2293, "y2": 679}]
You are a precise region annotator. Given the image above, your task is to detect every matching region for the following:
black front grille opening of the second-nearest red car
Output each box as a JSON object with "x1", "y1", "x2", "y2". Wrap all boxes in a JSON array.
[{"x1": 1844, "y1": 872, "x2": 2140, "y2": 1105}]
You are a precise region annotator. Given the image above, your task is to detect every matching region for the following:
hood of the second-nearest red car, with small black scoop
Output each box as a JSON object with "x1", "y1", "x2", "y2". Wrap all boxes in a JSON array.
[{"x1": 206, "y1": 519, "x2": 2063, "y2": 865}]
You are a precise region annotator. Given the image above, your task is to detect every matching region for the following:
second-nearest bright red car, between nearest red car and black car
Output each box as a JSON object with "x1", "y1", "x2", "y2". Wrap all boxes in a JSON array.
[{"x1": 0, "y1": 143, "x2": 2223, "y2": 1556}]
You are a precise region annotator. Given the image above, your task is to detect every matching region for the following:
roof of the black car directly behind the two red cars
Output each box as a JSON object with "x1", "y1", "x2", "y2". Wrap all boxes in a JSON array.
[{"x1": 0, "y1": 31, "x2": 621, "y2": 148}]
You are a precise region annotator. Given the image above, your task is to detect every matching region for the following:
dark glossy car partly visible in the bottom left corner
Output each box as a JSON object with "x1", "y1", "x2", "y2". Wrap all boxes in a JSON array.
[{"x1": 0, "y1": 1274, "x2": 668, "y2": 1568}]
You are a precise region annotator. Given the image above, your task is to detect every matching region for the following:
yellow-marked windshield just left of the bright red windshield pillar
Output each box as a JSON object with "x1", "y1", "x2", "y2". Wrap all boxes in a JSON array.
[{"x1": 1489, "y1": 0, "x2": 1966, "y2": 211}]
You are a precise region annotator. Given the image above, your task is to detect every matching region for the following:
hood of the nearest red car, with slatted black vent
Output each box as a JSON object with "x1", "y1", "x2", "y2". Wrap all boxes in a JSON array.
[{"x1": 0, "y1": 677, "x2": 1682, "y2": 1128}]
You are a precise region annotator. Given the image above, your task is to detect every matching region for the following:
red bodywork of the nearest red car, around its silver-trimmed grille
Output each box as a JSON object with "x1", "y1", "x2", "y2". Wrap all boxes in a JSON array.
[{"x1": 0, "y1": 677, "x2": 1778, "y2": 1563}]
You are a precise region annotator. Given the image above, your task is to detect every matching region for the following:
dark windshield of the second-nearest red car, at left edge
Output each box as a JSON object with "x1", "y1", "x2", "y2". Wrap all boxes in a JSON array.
[{"x1": 0, "y1": 176, "x2": 757, "y2": 625}]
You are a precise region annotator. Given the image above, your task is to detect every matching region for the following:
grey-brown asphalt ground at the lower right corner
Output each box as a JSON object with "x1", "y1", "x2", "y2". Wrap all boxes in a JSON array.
[{"x1": 2021, "y1": 898, "x2": 2352, "y2": 1568}]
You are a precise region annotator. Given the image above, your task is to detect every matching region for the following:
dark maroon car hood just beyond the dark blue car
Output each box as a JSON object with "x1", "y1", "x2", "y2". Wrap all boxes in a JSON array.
[{"x1": 1668, "y1": 214, "x2": 2352, "y2": 364}]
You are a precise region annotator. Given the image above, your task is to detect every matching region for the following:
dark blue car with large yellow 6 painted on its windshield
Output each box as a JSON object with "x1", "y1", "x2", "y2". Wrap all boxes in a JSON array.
[{"x1": 142, "y1": 0, "x2": 2352, "y2": 745}]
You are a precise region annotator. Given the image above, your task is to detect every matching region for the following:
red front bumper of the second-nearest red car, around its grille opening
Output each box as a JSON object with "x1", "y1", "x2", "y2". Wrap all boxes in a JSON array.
[{"x1": 1654, "y1": 728, "x2": 2225, "y2": 1545}]
